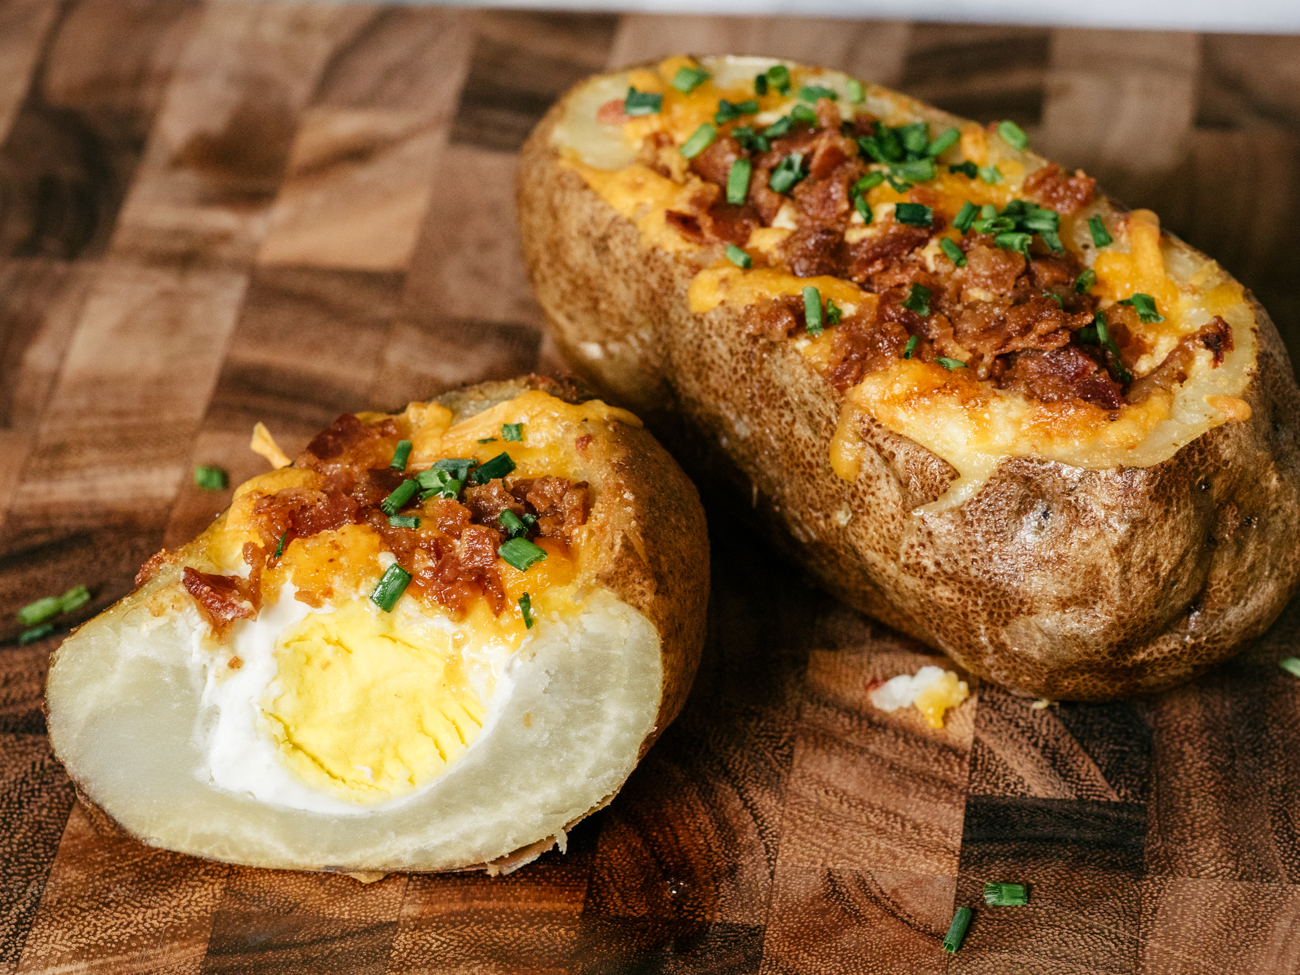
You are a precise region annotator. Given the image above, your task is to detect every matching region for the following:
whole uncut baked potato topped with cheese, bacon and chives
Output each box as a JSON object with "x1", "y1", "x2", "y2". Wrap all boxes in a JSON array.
[{"x1": 517, "y1": 57, "x2": 1300, "y2": 699}]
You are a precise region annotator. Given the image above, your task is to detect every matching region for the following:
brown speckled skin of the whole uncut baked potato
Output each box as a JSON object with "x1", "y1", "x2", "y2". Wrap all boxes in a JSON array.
[{"x1": 517, "y1": 99, "x2": 1300, "y2": 701}]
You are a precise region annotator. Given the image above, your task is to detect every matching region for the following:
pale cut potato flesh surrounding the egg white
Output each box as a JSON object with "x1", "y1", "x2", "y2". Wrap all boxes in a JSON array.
[{"x1": 47, "y1": 572, "x2": 662, "y2": 871}]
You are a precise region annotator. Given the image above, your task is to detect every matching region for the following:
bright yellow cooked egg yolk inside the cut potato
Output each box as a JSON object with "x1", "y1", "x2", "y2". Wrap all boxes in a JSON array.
[{"x1": 263, "y1": 601, "x2": 485, "y2": 803}]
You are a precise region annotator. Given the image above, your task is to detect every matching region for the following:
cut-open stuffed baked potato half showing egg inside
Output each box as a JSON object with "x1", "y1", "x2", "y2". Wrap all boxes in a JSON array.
[{"x1": 47, "y1": 377, "x2": 709, "y2": 874}]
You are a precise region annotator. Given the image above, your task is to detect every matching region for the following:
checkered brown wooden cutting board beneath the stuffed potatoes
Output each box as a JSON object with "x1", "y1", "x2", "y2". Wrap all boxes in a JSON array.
[{"x1": 0, "y1": 0, "x2": 1300, "y2": 975}]
